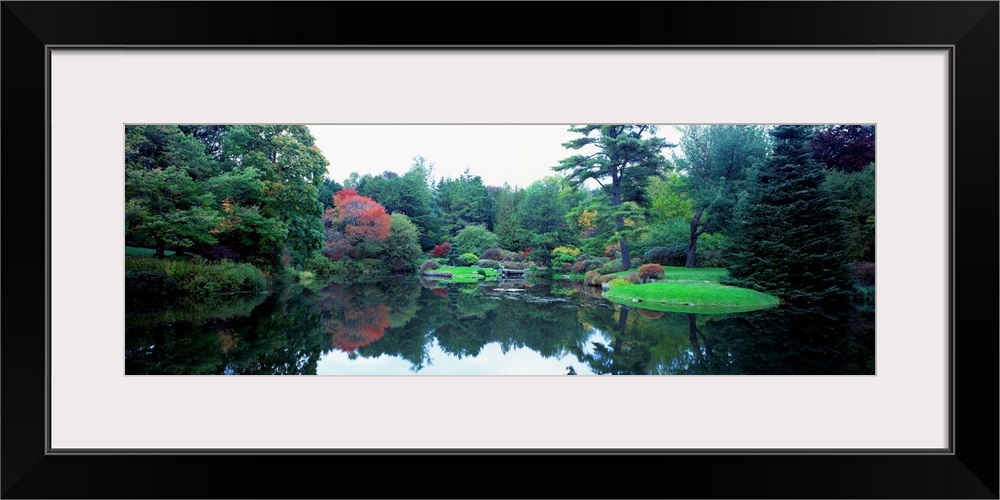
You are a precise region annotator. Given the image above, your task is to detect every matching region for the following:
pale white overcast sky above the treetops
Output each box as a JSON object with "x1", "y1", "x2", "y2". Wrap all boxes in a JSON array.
[{"x1": 309, "y1": 125, "x2": 678, "y2": 188}]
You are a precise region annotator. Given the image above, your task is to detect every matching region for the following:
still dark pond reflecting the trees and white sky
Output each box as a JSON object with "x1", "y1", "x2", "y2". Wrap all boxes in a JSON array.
[{"x1": 125, "y1": 277, "x2": 875, "y2": 376}]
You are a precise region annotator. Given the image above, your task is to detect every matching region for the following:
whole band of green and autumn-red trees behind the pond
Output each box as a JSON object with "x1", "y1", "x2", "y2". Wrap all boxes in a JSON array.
[{"x1": 125, "y1": 125, "x2": 875, "y2": 300}]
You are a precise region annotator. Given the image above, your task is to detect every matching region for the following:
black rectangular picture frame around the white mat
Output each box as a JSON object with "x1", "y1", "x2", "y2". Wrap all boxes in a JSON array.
[{"x1": 0, "y1": 1, "x2": 1000, "y2": 498}]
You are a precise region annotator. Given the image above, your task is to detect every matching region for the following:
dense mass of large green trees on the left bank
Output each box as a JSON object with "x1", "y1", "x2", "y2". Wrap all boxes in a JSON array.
[{"x1": 125, "y1": 125, "x2": 328, "y2": 269}]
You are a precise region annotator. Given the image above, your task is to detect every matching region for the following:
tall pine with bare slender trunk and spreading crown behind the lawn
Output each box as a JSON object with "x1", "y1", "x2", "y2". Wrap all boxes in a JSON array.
[{"x1": 554, "y1": 125, "x2": 671, "y2": 268}]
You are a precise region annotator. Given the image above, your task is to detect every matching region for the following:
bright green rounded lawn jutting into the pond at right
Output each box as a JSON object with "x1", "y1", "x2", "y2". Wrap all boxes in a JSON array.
[{"x1": 604, "y1": 282, "x2": 780, "y2": 313}]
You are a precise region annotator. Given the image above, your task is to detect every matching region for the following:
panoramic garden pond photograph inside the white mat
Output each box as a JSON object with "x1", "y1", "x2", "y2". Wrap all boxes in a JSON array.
[{"x1": 124, "y1": 123, "x2": 876, "y2": 376}]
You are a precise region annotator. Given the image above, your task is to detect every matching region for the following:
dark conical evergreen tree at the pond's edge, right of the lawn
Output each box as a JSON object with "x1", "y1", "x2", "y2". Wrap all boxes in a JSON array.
[{"x1": 727, "y1": 125, "x2": 849, "y2": 303}]
